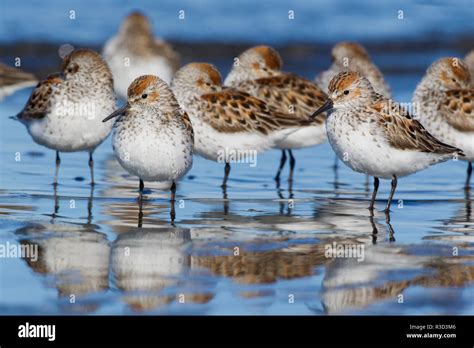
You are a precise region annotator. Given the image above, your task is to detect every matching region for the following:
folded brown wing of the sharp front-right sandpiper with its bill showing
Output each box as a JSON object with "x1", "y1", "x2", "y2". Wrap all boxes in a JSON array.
[{"x1": 371, "y1": 96, "x2": 462, "y2": 155}]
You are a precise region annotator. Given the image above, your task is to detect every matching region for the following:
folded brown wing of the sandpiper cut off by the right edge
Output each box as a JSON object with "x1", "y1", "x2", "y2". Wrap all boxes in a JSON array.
[{"x1": 439, "y1": 89, "x2": 474, "y2": 132}]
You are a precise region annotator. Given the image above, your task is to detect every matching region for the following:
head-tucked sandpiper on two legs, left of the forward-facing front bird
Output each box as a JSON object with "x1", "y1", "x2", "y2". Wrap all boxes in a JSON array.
[{"x1": 15, "y1": 49, "x2": 116, "y2": 185}]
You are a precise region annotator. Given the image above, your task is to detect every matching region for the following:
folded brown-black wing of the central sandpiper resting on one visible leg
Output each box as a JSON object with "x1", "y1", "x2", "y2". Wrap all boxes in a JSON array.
[{"x1": 198, "y1": 88, "x2": 308, "y2": 134}]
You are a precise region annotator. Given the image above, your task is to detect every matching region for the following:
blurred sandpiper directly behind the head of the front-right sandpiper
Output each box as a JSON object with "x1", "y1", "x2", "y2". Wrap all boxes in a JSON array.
[{"x1": 315, "y1": 41, "x2": 391, "y2": 98}]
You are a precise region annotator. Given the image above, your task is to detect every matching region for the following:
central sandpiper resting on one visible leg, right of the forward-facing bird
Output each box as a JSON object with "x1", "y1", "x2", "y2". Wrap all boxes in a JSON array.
[{"x1": 171, "y1": 63, "x2": 309, "y2": 188}]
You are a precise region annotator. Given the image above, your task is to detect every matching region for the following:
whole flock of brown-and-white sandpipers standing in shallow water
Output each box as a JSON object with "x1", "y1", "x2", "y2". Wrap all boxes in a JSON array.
[{"x1": 4, "y1": 13, "x2": 474, "y2": 221}]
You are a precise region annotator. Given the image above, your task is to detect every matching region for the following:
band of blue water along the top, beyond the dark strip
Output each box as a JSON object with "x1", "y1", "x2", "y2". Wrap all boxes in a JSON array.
[{"x1": 0, "y1": 0, "x2": 474, "y2": 44}]
